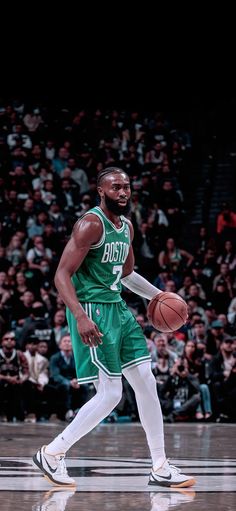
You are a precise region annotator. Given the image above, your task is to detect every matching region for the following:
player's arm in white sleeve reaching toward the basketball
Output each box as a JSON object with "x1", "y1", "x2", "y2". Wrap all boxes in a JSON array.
[{"x1": 121, "y1": 222, "x2": 162, "y2": 300}]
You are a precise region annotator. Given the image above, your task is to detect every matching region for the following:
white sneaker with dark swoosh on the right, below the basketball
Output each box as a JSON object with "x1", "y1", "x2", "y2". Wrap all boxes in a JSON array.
[{"x1": 148, "y1": 460, "x2": 196, "y2": 488}]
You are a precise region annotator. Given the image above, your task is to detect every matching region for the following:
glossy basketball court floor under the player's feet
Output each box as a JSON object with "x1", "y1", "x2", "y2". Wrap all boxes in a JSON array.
[{"x1": 0, "y1": 422, "x2": 236, "y2": 511}]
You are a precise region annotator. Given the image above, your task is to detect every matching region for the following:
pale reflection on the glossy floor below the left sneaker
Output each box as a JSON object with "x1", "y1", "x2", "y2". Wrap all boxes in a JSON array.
[{"x1": 32, "y1": 486, "x2": 75, "y2": 511}]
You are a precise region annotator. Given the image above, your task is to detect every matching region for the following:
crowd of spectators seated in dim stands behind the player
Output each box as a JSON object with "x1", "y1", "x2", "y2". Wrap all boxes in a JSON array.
[{"x1": 0, "y1": 100, "x2": 236, "y2": 422}]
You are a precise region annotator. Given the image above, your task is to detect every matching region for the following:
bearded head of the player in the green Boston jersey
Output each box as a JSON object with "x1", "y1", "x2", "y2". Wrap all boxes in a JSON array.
[{"x1": 99, "y1": 173, "x2": 131, "y2": 215}]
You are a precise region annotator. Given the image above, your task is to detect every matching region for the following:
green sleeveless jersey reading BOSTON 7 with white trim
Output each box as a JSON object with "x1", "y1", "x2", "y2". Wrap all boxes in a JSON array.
[{"x1": 72, "y1": 206, "x2": 130, "y2": 303}]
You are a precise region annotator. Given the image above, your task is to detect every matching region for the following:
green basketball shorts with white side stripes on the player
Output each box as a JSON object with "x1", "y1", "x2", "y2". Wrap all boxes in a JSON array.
[{"x1": 66, "y1": 300, "x2": 151, "y2": 383}]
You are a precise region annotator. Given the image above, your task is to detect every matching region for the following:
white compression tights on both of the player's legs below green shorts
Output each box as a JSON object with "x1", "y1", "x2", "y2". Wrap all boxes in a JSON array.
[{"x1": 46, "y1": 362, "x2": 165, "y2": 466}]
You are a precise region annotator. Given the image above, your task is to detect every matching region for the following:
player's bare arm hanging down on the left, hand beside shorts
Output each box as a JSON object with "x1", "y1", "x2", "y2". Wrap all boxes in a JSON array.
[{"x1": 55, "y1": 214, "x2": 102, "y2": 346}]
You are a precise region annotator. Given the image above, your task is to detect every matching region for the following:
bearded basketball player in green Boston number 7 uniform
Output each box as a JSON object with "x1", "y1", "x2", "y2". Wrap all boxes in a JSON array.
[{"x1": 33, "y1": 167, "x2": 195, "y2": 487}]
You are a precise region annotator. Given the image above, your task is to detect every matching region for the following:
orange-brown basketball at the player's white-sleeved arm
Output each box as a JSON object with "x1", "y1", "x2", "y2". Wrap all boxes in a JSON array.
[{"x1": 147, "y1": 292, "x2": 188, "y2": 333}]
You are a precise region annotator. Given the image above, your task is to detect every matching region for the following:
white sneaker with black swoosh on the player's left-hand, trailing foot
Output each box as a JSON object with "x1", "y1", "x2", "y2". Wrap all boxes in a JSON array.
[{"x1": 33, "y1": 445, "x2": 76, "y2": 486}]
